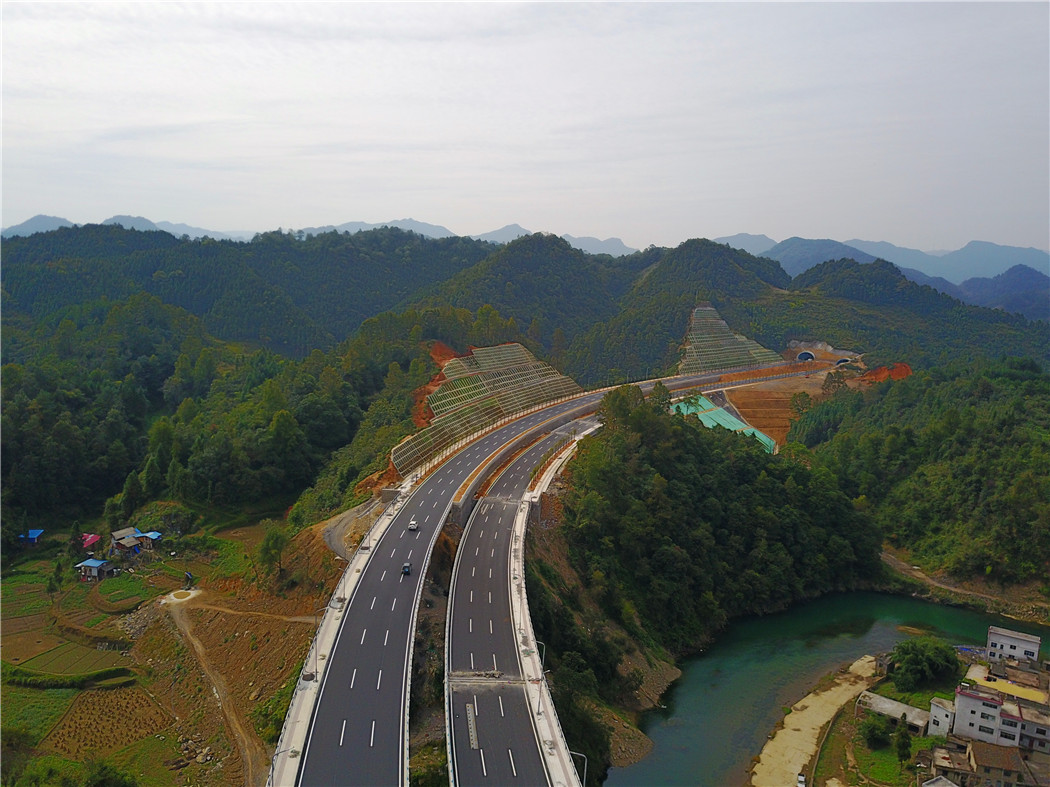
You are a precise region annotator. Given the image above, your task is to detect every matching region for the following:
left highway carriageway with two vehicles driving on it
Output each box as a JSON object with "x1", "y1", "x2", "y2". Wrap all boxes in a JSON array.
[{"x1": 295, "y1": 374, "x2": 776, "y2": 787}]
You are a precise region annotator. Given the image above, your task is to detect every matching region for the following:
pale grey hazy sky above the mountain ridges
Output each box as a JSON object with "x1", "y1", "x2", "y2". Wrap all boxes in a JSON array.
[{"x1": 2, "y1": 1, "x2": 1050, "y2": 250}]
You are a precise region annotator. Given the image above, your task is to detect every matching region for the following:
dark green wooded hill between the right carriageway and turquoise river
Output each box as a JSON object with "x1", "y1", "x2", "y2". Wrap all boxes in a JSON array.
[{"x1": 565, "y1": 386, "x2": 881, "y2": 654}]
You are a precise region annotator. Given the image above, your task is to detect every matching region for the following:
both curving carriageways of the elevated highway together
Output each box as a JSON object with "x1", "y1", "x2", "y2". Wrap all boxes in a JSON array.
[{"x1": 268, "y1": 374, "x2": 785, "y2": 787}]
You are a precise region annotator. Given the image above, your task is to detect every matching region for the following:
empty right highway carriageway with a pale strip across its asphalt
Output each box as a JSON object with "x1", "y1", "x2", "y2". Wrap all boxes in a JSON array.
[{"x1": 446, "y1": 427, "x2": 567, "y2": 787}]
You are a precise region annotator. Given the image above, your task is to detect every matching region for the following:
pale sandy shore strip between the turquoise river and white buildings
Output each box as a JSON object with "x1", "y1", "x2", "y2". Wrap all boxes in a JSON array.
[{"x1": 751, "y1": 656, "x2": 875, "y2": 787}]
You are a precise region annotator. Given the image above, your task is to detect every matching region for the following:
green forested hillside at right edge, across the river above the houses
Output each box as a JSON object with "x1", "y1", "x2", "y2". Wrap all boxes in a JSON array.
[{"x1": 789, "y1": 359, "x2": 1050, "y2": 582}]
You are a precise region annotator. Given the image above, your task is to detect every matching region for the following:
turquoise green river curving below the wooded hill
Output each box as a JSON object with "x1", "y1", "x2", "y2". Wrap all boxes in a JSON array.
[{"x1": 606, "y1": 593, "x2": 1050, "y2": 787}]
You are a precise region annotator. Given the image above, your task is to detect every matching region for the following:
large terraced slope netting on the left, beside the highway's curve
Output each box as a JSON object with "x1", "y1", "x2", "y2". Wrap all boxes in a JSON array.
[{"x1": 391, "y1": 344, "x2": 583, "y2": 475}]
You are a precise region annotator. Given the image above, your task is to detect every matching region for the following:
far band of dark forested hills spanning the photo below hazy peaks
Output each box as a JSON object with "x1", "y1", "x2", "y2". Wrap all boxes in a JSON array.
[{"x1": 3, "y1": 225, "x2": 1047, "y2": 384}]
